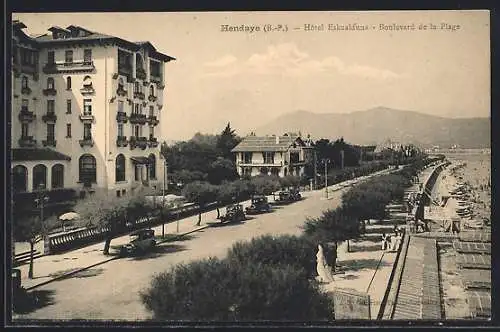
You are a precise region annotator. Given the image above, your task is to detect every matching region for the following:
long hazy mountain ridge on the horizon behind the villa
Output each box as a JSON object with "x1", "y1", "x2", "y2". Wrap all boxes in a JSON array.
[{"x1": 255, "y1": 107, "x2": 491, "y2": 148}]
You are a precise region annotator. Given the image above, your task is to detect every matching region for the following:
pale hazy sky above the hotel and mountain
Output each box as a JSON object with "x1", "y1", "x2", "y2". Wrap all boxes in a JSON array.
[{"x1": 13, "y1": 11, "x2": 490, "y2": 140}]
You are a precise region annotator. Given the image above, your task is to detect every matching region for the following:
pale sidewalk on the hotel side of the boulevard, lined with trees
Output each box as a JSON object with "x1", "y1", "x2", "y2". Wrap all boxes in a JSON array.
[{"x1": 16, "y1": 170, "x2": 391, "y2": 289}]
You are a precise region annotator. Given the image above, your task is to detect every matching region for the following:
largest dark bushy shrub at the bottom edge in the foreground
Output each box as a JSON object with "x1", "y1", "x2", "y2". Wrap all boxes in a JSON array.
[{"x1": 141, "y1": 258, "x2": 333, "y2": 321}]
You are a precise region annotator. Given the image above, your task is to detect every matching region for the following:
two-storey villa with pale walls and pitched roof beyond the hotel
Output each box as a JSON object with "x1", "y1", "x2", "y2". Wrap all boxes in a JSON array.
[{"x1": 232, "y1": 133, "x2": 314, "y2": 177}]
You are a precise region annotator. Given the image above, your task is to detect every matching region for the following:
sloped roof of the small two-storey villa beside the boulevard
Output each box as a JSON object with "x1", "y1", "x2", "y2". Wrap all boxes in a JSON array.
[{"x1": 231, "y1": 134, "x2": 305, "y2": 152}]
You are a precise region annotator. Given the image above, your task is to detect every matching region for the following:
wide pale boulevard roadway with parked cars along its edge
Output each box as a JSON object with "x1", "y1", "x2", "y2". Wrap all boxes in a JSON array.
[{"x1": 14, "y1": 170, "x2": 390, "y2": 320}]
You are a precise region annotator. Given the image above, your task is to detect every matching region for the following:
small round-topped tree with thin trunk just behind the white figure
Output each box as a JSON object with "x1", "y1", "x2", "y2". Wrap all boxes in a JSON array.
[{"x1": 303, "y1": 207, "x2": 360, "y2": 270}]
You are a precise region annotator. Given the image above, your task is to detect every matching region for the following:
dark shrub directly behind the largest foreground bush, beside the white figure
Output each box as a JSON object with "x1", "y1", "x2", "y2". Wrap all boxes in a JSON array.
[{"x1": 228, "y1": 235, "x2": 332, "y2": 277}]
